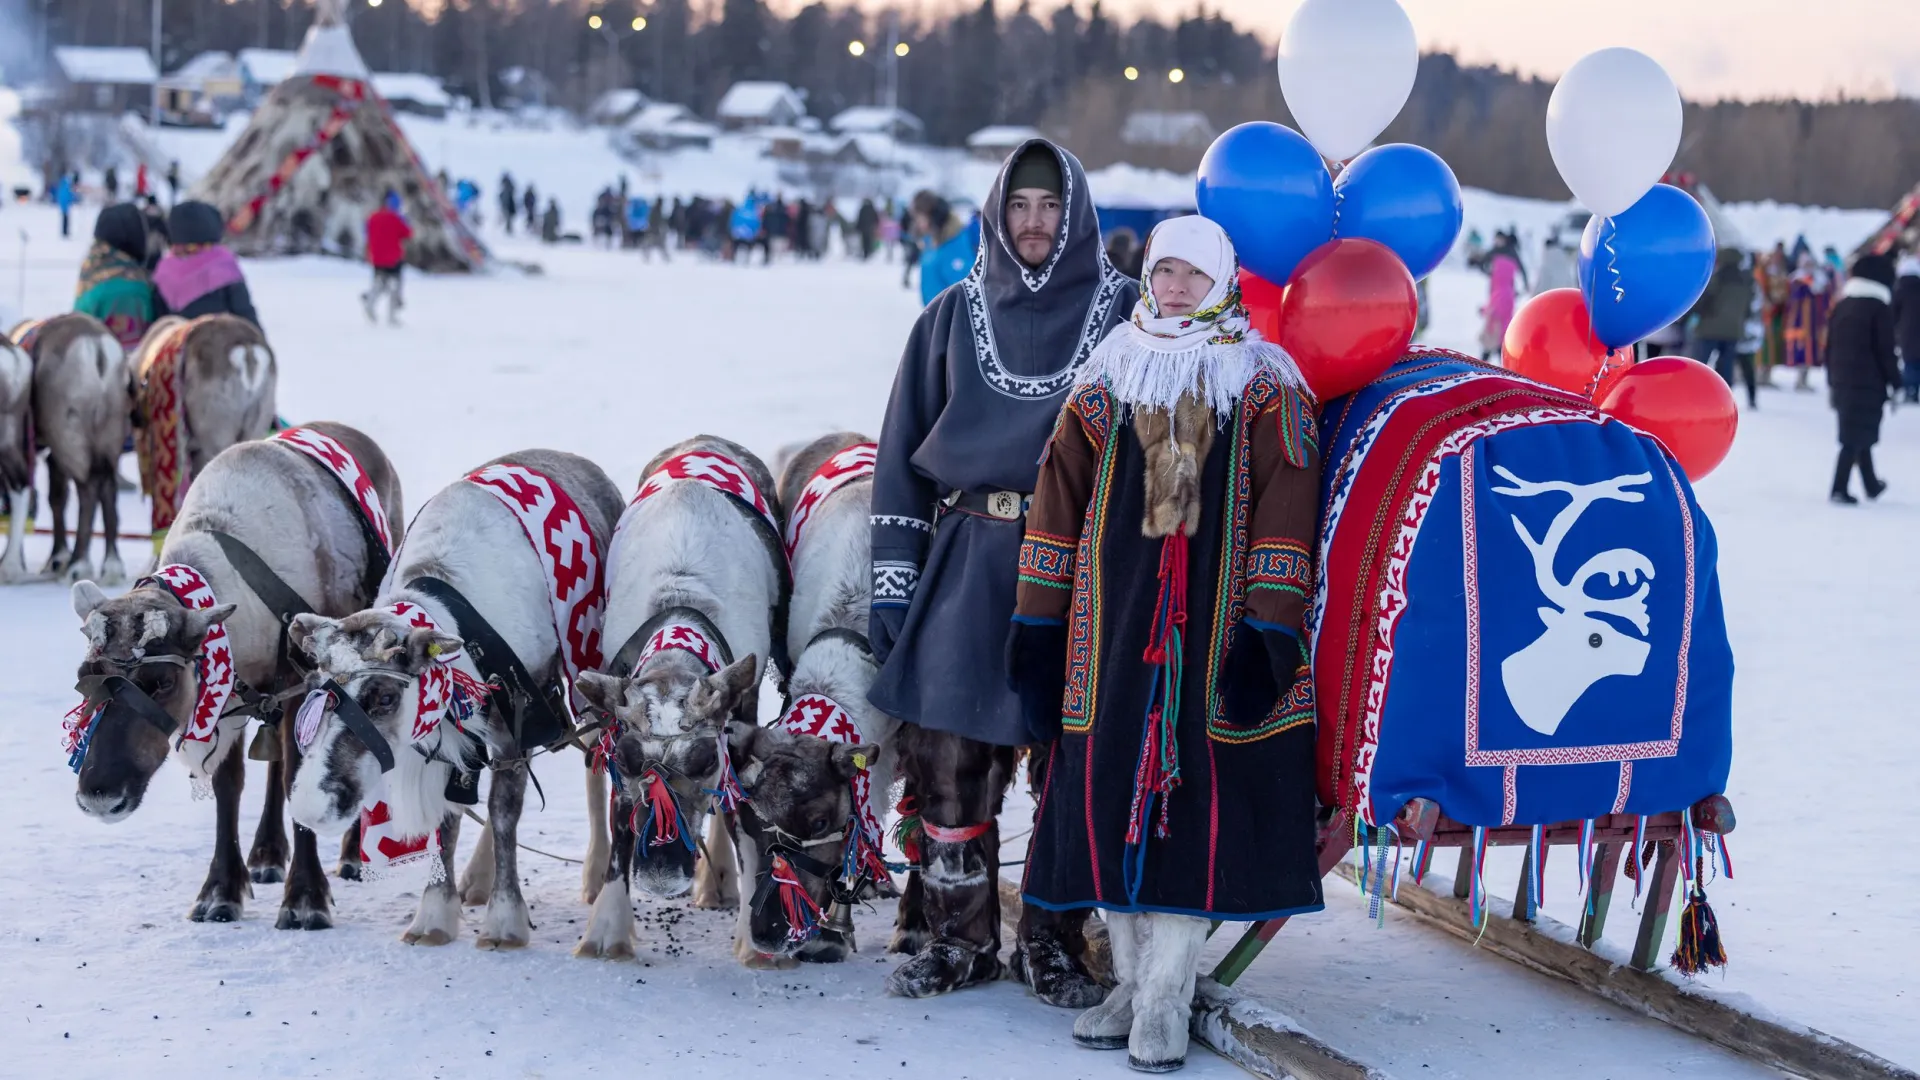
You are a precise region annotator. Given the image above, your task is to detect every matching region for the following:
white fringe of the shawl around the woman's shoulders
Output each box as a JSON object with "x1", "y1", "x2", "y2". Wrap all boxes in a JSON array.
[{"x1": 1075, "y1": 327, "x2": 1308, "y2": 427}]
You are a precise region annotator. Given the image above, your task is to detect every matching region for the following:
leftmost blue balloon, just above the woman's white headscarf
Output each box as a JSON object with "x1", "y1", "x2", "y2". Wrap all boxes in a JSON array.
[{"x1": 1194, "y1": 121, "x2": 1332, "y2": 284}]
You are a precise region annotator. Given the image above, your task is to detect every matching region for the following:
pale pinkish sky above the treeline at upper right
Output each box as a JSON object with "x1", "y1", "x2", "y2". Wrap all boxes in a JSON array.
[{"x1": 1077, "y1": 0, "x2": 1920, "y2": 98}]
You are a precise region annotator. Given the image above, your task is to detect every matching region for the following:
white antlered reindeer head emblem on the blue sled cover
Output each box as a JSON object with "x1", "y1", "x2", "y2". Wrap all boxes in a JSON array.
[{"x1": 1494, "y1": 465, "x2": 1653, "y2": 736}]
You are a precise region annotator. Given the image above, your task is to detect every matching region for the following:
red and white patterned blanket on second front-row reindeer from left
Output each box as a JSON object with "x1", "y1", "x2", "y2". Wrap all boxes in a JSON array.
[{"x1": 467, "y1": 465, "x2": 607, "y2": 721}]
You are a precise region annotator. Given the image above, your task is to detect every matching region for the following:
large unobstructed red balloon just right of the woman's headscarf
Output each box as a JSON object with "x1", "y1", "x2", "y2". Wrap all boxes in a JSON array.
[{"x1": 1275, "y1": 238, "x2": 1419, "y2": 402}]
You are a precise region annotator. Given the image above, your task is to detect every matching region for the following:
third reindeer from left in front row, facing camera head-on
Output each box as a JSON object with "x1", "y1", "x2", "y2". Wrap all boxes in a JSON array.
[{"x1": 574, "y1": 436, "x2": 787, "y2": 963}]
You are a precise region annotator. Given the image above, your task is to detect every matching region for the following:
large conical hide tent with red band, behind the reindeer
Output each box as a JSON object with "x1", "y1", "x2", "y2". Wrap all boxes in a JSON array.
[{"x1": 194, "y1": 0, "x2": 488, "y2": 271}]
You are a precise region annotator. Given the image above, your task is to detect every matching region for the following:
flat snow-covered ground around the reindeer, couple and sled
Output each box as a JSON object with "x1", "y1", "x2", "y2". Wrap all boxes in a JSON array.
[{"x1": 0, "y1": 197, "x2": 1920, "y2": 1080}]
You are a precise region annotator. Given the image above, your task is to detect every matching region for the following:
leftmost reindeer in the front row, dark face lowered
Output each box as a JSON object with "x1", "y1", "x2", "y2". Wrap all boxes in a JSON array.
[{"x1": 73, "y1": 423, "x2": 405, "y2": 930}]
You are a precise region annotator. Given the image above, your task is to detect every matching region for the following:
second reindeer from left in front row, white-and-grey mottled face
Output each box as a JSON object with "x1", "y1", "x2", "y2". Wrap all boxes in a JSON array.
[{"x1": 290, "y1": 450, "x2": 620, "y2": 949}]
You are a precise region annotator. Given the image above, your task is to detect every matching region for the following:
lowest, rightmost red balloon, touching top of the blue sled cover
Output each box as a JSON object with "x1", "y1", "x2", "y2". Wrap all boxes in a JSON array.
[{"x1": 1599, "y1": 356, "x2": 1740, "y2": 480}]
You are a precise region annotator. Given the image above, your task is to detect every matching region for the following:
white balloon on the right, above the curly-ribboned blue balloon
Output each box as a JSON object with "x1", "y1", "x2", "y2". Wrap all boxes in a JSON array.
[{"x1": 1548, "y1": 48, "x2": 1680, "y2": 217}]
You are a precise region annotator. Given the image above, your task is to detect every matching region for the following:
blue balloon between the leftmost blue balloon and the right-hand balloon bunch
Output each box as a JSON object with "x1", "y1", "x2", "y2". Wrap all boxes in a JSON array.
[{"x1": 1332, "y1": 142, "x2": 1467, "y2": 279}]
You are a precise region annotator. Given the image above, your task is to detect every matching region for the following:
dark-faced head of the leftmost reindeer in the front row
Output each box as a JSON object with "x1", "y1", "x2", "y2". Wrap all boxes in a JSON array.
[{"x1": 73, "y1": 580, "x2": 234, "y2": 821}]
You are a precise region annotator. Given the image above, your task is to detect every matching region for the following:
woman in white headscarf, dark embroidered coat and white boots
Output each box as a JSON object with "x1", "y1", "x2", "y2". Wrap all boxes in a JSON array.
[{"x1": 1008, "y1": 217, "x2": 1321, "y2": 1072}]
